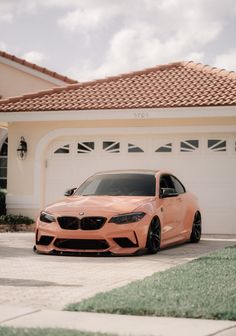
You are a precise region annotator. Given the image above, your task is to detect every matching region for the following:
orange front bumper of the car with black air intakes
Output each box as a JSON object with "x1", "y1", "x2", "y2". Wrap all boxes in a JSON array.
[{"x1": 36, "y1": 215, "x2": 150, "y2": 254}]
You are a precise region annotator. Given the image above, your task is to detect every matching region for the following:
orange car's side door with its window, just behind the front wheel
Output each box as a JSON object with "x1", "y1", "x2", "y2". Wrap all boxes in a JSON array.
[{"x1": 159, "y1": 174, "x2": 185, "y2": 243}]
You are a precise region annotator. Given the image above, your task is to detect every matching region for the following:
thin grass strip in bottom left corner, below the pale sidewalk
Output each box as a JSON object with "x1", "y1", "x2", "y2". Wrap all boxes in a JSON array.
[{"x1": 0, "y1": 327, "x2": 114, "y2": 336}]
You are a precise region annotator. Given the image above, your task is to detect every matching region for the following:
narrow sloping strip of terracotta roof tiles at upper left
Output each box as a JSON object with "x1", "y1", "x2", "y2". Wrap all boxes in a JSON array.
[{"x1": 0, "y1": 51, "x2": 78, "y2": 84}]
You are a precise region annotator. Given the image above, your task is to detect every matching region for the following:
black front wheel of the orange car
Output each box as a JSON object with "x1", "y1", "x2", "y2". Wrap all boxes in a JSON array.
[{"x1": 146, "y1": 218, "x2": 161, "y2": 254}]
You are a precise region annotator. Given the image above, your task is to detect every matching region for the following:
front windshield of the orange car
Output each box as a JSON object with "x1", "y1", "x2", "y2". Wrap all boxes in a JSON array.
[{"x1": 75, "y1": 174, "x2": 156, "y2": 196}]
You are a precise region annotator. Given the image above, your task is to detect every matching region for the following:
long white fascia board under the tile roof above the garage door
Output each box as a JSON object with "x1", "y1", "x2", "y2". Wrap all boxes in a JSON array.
[{"x1": 0, "y1": 106, "x2": 236, "y2": 122}]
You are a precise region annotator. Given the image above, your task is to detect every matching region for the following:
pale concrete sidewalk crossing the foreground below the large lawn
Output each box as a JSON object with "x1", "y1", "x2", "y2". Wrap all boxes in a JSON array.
[{"x1": 0, "y1": 305, "x2": 236, "y2": 336}]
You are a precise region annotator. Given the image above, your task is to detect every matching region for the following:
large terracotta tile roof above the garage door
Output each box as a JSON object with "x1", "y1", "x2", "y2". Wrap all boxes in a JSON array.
[{"x1": 0, "y1": 62, "x2": 236, "y2": 112}]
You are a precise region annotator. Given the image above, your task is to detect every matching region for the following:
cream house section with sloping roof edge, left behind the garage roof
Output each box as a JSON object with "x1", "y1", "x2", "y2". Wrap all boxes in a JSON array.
[{"x1": 0, "y1": 51, "x2": 77, "y2": 188}]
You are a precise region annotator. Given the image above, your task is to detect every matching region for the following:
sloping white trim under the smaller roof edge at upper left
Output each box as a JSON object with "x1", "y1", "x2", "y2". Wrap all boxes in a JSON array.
[{"x1": 0, "y1": 56, "x2": 69, "y2": 86}]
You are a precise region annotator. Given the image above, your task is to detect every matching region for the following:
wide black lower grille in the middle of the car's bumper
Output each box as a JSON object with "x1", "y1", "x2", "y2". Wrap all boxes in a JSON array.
[{"x1": 54, "y1": 238, "x2": 109, "y2": 250}]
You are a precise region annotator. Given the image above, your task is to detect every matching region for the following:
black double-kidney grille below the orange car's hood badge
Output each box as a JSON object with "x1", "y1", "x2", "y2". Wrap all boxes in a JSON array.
[{"x1": 57, "y1": 216, "x2": 106, "y2": 230}]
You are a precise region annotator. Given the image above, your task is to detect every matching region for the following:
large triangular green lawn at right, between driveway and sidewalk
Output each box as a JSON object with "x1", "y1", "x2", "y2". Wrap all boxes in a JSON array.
[{"x1": 65, "y1": 246, "x2": 236, "y2": 320}]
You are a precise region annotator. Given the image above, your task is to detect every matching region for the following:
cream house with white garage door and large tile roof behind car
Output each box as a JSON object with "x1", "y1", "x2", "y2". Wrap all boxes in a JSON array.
[{"x1": 0, "y1": 62, "x2": 236, "y2": 234}]
